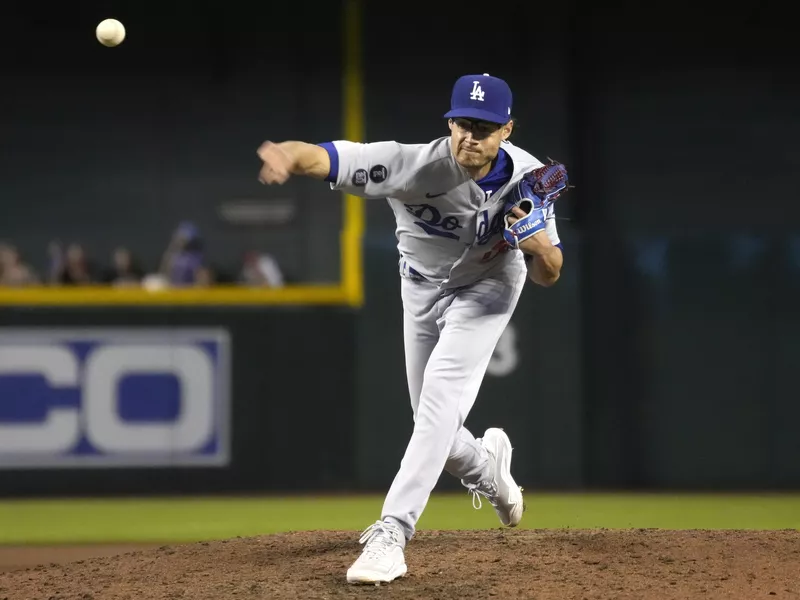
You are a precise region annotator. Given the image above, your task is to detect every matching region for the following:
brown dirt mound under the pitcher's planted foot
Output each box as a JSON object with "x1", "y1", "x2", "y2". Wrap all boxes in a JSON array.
[{"x1": 0, "y1": 530, "x2": 800, "y2": 600}]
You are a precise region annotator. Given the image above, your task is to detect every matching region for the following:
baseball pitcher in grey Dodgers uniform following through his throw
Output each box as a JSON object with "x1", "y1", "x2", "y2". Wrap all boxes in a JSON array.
[{"x1": 258, "y1": 73, "x2": 567, "y2": 583}]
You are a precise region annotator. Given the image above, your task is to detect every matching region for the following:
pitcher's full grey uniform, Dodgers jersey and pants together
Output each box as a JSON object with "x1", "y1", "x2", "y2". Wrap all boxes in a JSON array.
[{"x1": 321, "y1": 137, "x2": 560, "y2": 539}]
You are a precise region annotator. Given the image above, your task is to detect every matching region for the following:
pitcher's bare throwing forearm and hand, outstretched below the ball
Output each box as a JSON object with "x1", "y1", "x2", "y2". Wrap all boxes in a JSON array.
[{"x1": 257, "y1": 141, "x2": 331, "y2": 185}]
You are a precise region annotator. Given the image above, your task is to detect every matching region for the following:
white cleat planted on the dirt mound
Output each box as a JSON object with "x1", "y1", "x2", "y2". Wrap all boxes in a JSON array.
[{"x1": 347, "y1": 521, "x2": 408, "y2": 583}]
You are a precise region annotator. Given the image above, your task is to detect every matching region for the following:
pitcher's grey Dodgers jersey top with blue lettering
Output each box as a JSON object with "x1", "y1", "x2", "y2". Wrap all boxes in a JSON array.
[{"x1": 321, "y1": 136, "x2": 560, "y2": 288}]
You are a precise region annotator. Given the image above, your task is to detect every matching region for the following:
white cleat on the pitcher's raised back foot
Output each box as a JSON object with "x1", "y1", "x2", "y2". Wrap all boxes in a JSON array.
[{"x1": 462, "y1": 427, "x2": 525, "y2": 527}]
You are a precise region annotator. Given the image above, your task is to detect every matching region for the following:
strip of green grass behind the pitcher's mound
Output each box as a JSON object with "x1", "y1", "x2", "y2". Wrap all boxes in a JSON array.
[{"x1": 0, "y1": 493, "x2": 800, "y2": 544}]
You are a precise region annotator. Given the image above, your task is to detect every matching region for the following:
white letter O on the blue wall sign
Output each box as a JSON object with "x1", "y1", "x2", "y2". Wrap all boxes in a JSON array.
[{"x1": 83, "y1": 345, "x2": 214, "y2": 454}]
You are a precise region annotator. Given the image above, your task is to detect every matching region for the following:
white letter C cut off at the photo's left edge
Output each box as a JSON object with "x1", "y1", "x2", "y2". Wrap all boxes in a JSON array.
[{"x1": 0, "y1": 346, "x2": 81, "y2": 454}]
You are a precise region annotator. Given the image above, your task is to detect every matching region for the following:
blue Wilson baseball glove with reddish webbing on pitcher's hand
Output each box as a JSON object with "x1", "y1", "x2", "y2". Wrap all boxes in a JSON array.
[{"x1": 503, "y1": 159, "x2": 570, "y2": 248}]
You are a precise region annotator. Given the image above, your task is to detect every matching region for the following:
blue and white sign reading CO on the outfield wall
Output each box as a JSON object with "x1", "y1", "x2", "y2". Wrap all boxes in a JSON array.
[{"x1": 0, "y1": 328, "x2": 231, "y2": 469}]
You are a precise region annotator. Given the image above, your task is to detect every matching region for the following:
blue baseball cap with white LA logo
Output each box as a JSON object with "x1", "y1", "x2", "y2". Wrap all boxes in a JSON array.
[{"x1": 444, "y1": 73, "x2": 512, "y2": 124}]
